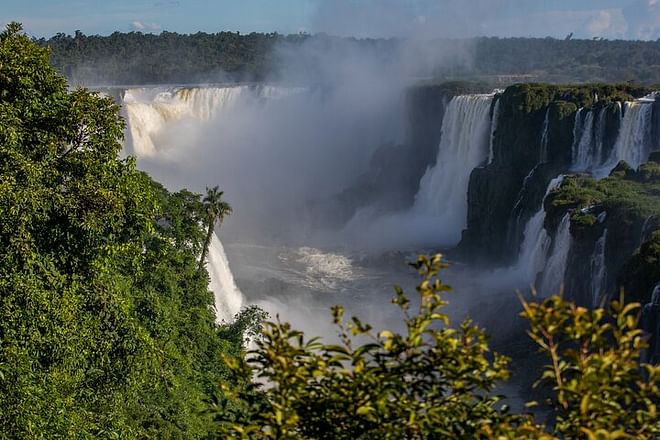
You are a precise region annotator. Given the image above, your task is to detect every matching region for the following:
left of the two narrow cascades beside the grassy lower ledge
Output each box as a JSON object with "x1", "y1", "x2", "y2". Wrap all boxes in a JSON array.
[{"x1": 516, "y1": 176, "x2": 564, "y2": 283}]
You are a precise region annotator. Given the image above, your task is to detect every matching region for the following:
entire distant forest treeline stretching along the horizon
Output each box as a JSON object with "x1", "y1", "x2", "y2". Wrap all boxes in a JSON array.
[{"x1": 37, "y1": 31, "x2": 660, "y2": 85}]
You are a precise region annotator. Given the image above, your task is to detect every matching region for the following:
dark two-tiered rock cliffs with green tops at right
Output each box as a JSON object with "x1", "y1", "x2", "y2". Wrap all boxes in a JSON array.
[{"x1": 458, "y1": 84, "x2": 660, "y2": 306}]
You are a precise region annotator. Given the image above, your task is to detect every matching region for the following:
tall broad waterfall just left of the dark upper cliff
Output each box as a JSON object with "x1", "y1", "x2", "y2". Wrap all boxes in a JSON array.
[{"x1": 413, "y1": 95, "x2": 493, "y2": 244}]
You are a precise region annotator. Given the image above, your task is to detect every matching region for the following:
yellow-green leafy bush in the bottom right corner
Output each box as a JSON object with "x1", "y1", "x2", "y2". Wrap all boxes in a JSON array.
[{"x1": 522, "y1": 295, "x2": 660, "y2": 439}]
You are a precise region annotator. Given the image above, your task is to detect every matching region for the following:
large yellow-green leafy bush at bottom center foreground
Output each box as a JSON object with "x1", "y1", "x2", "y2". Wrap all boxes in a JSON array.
[{"x1": 217, "y1": 256, "x2": 540, "y2": 439}]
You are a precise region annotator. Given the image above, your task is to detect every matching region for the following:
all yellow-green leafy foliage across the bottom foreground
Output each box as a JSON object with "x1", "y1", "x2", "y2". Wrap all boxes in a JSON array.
[{"x1": 221, "y1": 256, "x2": 660, "y2": 439}]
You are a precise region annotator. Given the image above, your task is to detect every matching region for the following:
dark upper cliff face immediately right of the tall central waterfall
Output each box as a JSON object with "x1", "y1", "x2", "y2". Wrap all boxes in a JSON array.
[{"x1": 459, "y1": 84, "x2": 643, "y2": 264}]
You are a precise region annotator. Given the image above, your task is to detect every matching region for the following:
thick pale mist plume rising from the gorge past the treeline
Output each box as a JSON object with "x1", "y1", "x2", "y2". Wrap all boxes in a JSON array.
[{"x1": 125, "y1": 32, "x2": 474, "y2": 245}]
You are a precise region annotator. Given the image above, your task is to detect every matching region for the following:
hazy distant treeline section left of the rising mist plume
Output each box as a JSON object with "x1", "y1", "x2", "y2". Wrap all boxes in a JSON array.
[{"x1": 38, "y1": 31, "x2": 301, "y2": 85}]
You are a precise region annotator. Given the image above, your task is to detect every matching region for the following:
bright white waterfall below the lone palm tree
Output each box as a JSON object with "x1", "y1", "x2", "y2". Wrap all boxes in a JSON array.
[{"x1": 207, "y1": 233, "x2": 243, "y2": 323}]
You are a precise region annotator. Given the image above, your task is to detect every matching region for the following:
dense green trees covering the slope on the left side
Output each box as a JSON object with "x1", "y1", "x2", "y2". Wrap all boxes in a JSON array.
[{"x1": 0, "y1": 24, "x2": 254, "y2": 439}]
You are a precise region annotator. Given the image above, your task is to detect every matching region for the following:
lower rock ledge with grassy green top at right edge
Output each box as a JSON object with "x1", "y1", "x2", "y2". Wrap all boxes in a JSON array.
[{"x1": 546, "y1": 156, "x2": 660, "y2": 306}]
